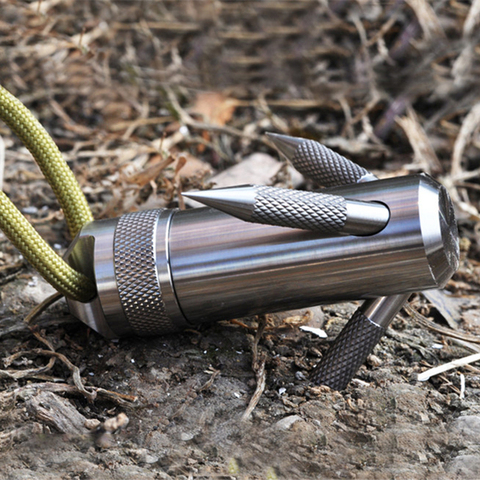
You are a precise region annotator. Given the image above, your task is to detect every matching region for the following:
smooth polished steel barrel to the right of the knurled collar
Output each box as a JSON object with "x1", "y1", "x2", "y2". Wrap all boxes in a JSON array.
[{"x1": 170, "y1": 175, "x2": 456, "y2": 323}]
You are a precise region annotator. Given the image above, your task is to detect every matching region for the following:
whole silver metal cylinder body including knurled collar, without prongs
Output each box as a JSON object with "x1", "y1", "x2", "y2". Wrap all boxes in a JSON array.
[{"x1": 65, "y1": 175, "x2": 458, "y2": 336}]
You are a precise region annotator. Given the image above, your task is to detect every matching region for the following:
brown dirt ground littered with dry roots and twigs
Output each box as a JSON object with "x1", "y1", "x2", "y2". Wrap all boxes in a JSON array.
[{"x1": 0, "y1": 0, "x2": 480, "y2": 480}]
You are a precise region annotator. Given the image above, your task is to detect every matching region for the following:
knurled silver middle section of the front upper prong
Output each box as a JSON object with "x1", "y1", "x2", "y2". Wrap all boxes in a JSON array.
[{"x1": 252, "y1": 186, "x2": 347, "y2": 233}]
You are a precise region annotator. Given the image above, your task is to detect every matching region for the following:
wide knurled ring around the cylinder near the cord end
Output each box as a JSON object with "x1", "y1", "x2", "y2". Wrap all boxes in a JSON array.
[{"x1": 114, "y1": 210, "x2": 176, "y2": 336}]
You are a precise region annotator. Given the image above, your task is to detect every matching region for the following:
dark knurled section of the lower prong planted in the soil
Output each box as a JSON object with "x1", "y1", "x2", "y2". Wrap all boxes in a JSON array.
[{"x1": 311, "y1": 310, "x2": 385, "y2": 390}]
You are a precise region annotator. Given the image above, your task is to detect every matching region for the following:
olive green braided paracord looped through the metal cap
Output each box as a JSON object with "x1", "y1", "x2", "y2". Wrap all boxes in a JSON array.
[{"x1": 0, "y1": 85, "x2": 95, "y2": 302}]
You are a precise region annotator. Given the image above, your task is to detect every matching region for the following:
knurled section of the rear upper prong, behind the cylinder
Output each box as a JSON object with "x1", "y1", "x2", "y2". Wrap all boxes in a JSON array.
[{"x1": 291, "y1": 140, "x2": 369, "y2": 187}]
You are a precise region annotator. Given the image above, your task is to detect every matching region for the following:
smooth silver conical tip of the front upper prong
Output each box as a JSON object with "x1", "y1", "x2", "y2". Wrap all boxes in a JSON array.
[{"x1": 182, "y1": 185, "x2": 256, "y2": 220}]
